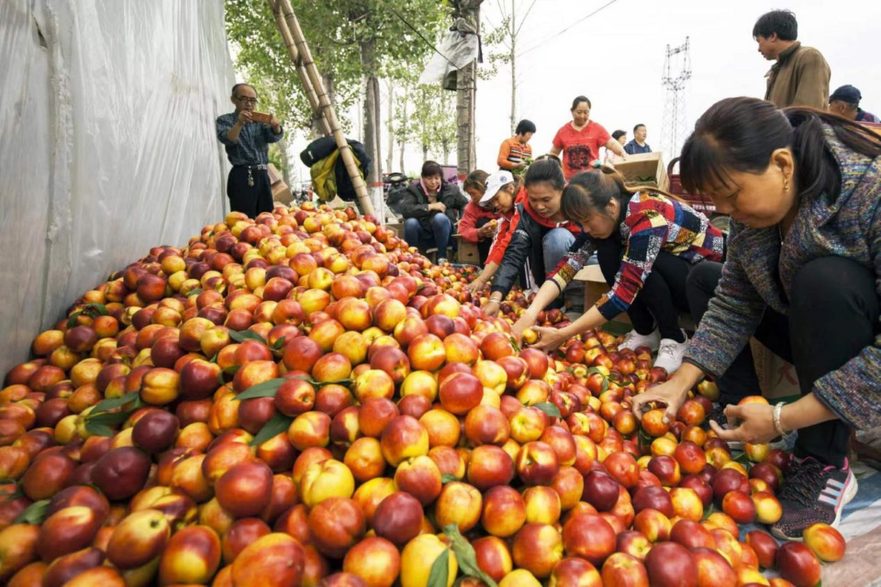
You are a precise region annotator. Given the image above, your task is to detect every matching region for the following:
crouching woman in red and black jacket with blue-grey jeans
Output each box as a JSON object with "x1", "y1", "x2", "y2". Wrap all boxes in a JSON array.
[{"x1": 478, "y1": 159, "x2": 583, "y2": 316}]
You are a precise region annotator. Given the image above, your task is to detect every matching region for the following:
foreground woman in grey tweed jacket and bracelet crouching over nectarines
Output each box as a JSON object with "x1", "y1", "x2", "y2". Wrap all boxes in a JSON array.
[{"x1": 633, "y1": 98, "x2": 881, "y2": 539}]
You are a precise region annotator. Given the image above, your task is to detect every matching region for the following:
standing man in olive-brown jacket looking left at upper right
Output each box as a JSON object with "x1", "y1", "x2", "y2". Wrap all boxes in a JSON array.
[{"x1": 753, "y1": 10, "x2": 832, "y2": 110}]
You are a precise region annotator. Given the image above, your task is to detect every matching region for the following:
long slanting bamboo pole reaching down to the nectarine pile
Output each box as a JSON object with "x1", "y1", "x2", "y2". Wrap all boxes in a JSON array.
[{"x1": 269, "y1": 0, "x2": 374, "y2": 214}]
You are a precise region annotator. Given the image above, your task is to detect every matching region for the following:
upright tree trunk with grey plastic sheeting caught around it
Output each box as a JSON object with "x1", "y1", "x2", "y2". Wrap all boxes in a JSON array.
[{"x1": 456, "y1": 0, "x2": 481, "y2": 179}]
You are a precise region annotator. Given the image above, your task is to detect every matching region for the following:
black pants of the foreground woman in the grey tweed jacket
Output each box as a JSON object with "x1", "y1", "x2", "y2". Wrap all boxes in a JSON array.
[{"x1": 688, "y1": 257, "x2": 881, "y2": 467}]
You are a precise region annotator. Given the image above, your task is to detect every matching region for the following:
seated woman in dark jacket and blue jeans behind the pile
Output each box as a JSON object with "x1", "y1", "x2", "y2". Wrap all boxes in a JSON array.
[{"x1": 400, "y1": 161, "x2": 468, "y2": 260}]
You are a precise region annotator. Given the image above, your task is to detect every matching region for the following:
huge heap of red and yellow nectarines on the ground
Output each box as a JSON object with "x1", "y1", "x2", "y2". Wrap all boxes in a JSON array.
[{"x1": 0, "y1": 204, "x2": 844, "y2": 587}]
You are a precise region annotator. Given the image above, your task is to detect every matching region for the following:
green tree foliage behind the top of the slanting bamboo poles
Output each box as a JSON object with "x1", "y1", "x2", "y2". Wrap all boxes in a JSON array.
[{"x1": 226, "y1": 0, "x2": 449, "y2": 135}]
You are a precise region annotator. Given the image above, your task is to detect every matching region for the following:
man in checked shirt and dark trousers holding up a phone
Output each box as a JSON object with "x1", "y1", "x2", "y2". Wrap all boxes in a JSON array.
[{"x1": 216, "y1": 84, "x2": 284, "y2": 218}]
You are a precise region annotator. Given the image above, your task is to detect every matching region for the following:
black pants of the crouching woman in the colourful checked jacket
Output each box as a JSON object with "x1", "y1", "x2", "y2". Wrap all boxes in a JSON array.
[{"x1": 597, "y1": 238, "x2": 692, "y2": 340}]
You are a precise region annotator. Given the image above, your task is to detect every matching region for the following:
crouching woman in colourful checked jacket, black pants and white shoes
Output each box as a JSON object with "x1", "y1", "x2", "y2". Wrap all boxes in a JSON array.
[{"x1": 513, "y1": 167, "x2": 725, "y2": 373}]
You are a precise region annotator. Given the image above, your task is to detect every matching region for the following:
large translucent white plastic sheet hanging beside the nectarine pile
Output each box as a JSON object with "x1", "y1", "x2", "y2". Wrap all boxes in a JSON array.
[{"x1": 0, "y1": 0, "x2": 234, "y2": 377}]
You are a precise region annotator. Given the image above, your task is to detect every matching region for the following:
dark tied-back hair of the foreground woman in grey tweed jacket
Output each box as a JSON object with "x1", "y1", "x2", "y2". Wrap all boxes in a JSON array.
[{"x1": 679, "y1": 98, "x2": 881, "y2": 200}]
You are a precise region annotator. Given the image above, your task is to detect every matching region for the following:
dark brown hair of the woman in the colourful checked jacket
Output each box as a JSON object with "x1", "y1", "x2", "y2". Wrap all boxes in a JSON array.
[{"x1": 560, "y1": 167, "x2": 636, "y2": 222}]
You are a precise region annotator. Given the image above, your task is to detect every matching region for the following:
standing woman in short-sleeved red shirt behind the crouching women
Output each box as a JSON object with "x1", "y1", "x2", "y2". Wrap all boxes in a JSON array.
[{"x1": 551, "y1": 96, "x2": 627, "y2": 181}]
